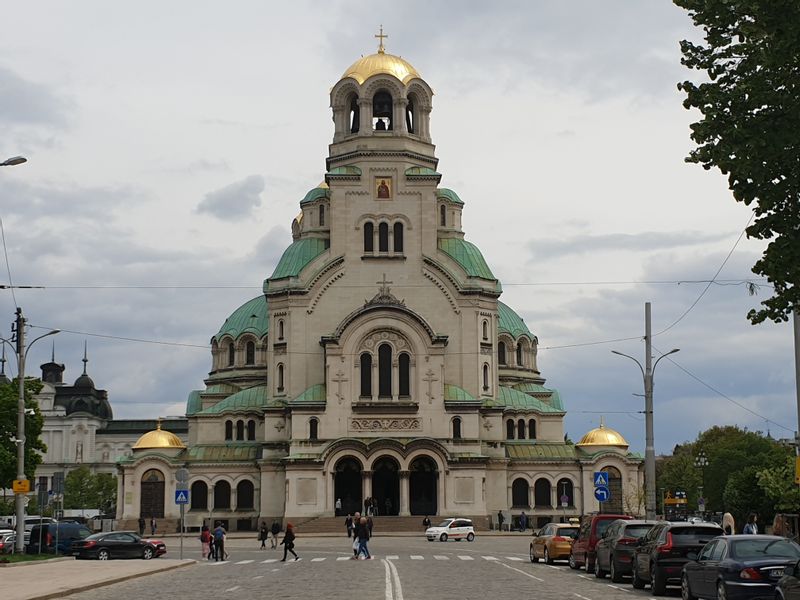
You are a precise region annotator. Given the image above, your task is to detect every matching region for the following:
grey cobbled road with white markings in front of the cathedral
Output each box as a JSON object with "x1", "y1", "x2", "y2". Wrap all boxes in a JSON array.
[{"x1": 61, "y1": 535, "x2": 680, "y2": 600}]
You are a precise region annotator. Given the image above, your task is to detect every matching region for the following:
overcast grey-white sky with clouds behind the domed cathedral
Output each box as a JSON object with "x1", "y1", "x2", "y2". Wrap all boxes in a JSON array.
[{"x1": 0, "y1": 0, "x2": 797, "y2": 452}]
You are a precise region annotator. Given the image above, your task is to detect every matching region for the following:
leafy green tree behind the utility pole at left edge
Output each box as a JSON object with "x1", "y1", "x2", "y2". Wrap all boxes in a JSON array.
[{"x1": 0, "y1": 377, "x2": 47, "y2": 489}]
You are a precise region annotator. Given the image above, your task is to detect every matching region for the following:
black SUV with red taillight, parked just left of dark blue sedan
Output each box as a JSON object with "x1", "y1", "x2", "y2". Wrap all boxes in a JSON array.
[{"x1": 632, "y1": 521, "x2": 723, "y2": 596}]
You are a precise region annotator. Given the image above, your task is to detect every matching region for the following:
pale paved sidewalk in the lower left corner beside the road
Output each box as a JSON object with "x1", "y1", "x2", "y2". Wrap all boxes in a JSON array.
[{"x1": 0, "y1": 558, "x2": 196, "y2": 600}]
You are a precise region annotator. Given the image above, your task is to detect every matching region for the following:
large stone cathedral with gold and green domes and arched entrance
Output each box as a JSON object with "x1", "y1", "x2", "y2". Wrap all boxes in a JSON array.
[{"x1": 118, "y1": 44, "x2": 642, "y2": 529}]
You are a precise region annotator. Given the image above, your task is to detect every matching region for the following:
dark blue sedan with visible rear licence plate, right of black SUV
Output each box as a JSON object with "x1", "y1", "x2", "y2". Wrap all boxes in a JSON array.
[{"x1": 681, "y1": 535, "x2": 800, "y2": 600}]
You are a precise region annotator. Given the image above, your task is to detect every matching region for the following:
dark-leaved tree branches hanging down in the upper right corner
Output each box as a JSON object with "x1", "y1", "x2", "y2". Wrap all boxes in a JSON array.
[{"x1": 674, "y1": 0, "x2": 800, "y2": 324}]
